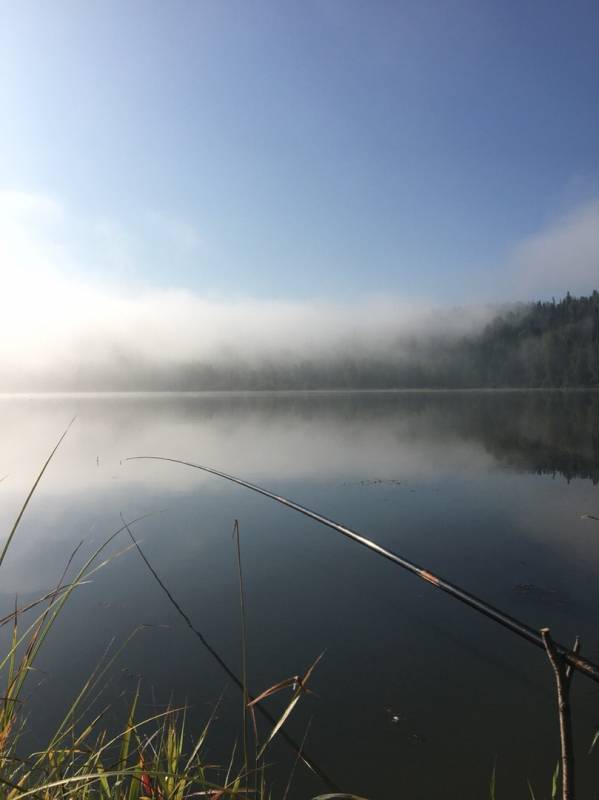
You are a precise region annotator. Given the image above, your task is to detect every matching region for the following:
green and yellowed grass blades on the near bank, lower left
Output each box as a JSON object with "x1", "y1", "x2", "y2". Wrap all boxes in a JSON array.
[{"x1": 0, "y1": 432, "x2": 366, "y2": 800}]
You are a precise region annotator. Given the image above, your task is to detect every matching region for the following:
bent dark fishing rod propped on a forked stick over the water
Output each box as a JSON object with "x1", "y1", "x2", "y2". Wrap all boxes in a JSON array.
[{"x1": 126, "y1": 456, "x2": 599, "y2": 683}]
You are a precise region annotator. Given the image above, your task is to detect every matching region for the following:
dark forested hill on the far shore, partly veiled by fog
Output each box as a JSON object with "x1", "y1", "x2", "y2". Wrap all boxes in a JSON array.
[{"x1": 167, "y1": 291, "x2": 599, "y2": 390}]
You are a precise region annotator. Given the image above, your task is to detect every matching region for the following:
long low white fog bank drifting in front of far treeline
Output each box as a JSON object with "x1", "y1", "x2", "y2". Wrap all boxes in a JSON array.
[{"x1": 0, "y1": 271, "x2": 493, "y2": 391}]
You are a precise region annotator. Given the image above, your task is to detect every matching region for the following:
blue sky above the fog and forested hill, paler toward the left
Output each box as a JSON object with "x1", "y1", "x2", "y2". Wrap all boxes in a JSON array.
[{"x1": 0, "y1": 0, "x2": 599, "y2": 304}]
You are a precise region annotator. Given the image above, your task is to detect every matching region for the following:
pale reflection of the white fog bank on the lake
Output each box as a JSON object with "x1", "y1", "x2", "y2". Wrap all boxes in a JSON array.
[{"x1": 0, "y1": 394, "x2": 492, "y2": 492}]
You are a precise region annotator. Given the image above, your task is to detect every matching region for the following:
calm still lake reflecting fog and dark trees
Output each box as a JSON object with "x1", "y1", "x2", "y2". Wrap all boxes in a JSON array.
[{"x1": 0, "y1": 391, "x2": 599, "y2": 800}]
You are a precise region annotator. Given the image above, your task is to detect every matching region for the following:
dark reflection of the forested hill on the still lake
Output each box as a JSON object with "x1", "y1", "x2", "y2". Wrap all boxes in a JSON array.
[{"x1": 172, "y1": 390, "x2": 599, "y2": 484}]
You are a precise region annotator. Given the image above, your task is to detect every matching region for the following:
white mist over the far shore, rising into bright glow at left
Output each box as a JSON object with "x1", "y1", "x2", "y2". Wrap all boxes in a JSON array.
[{"x1": 0, "y1": 198, "x2": 496, "y2": 391}]
